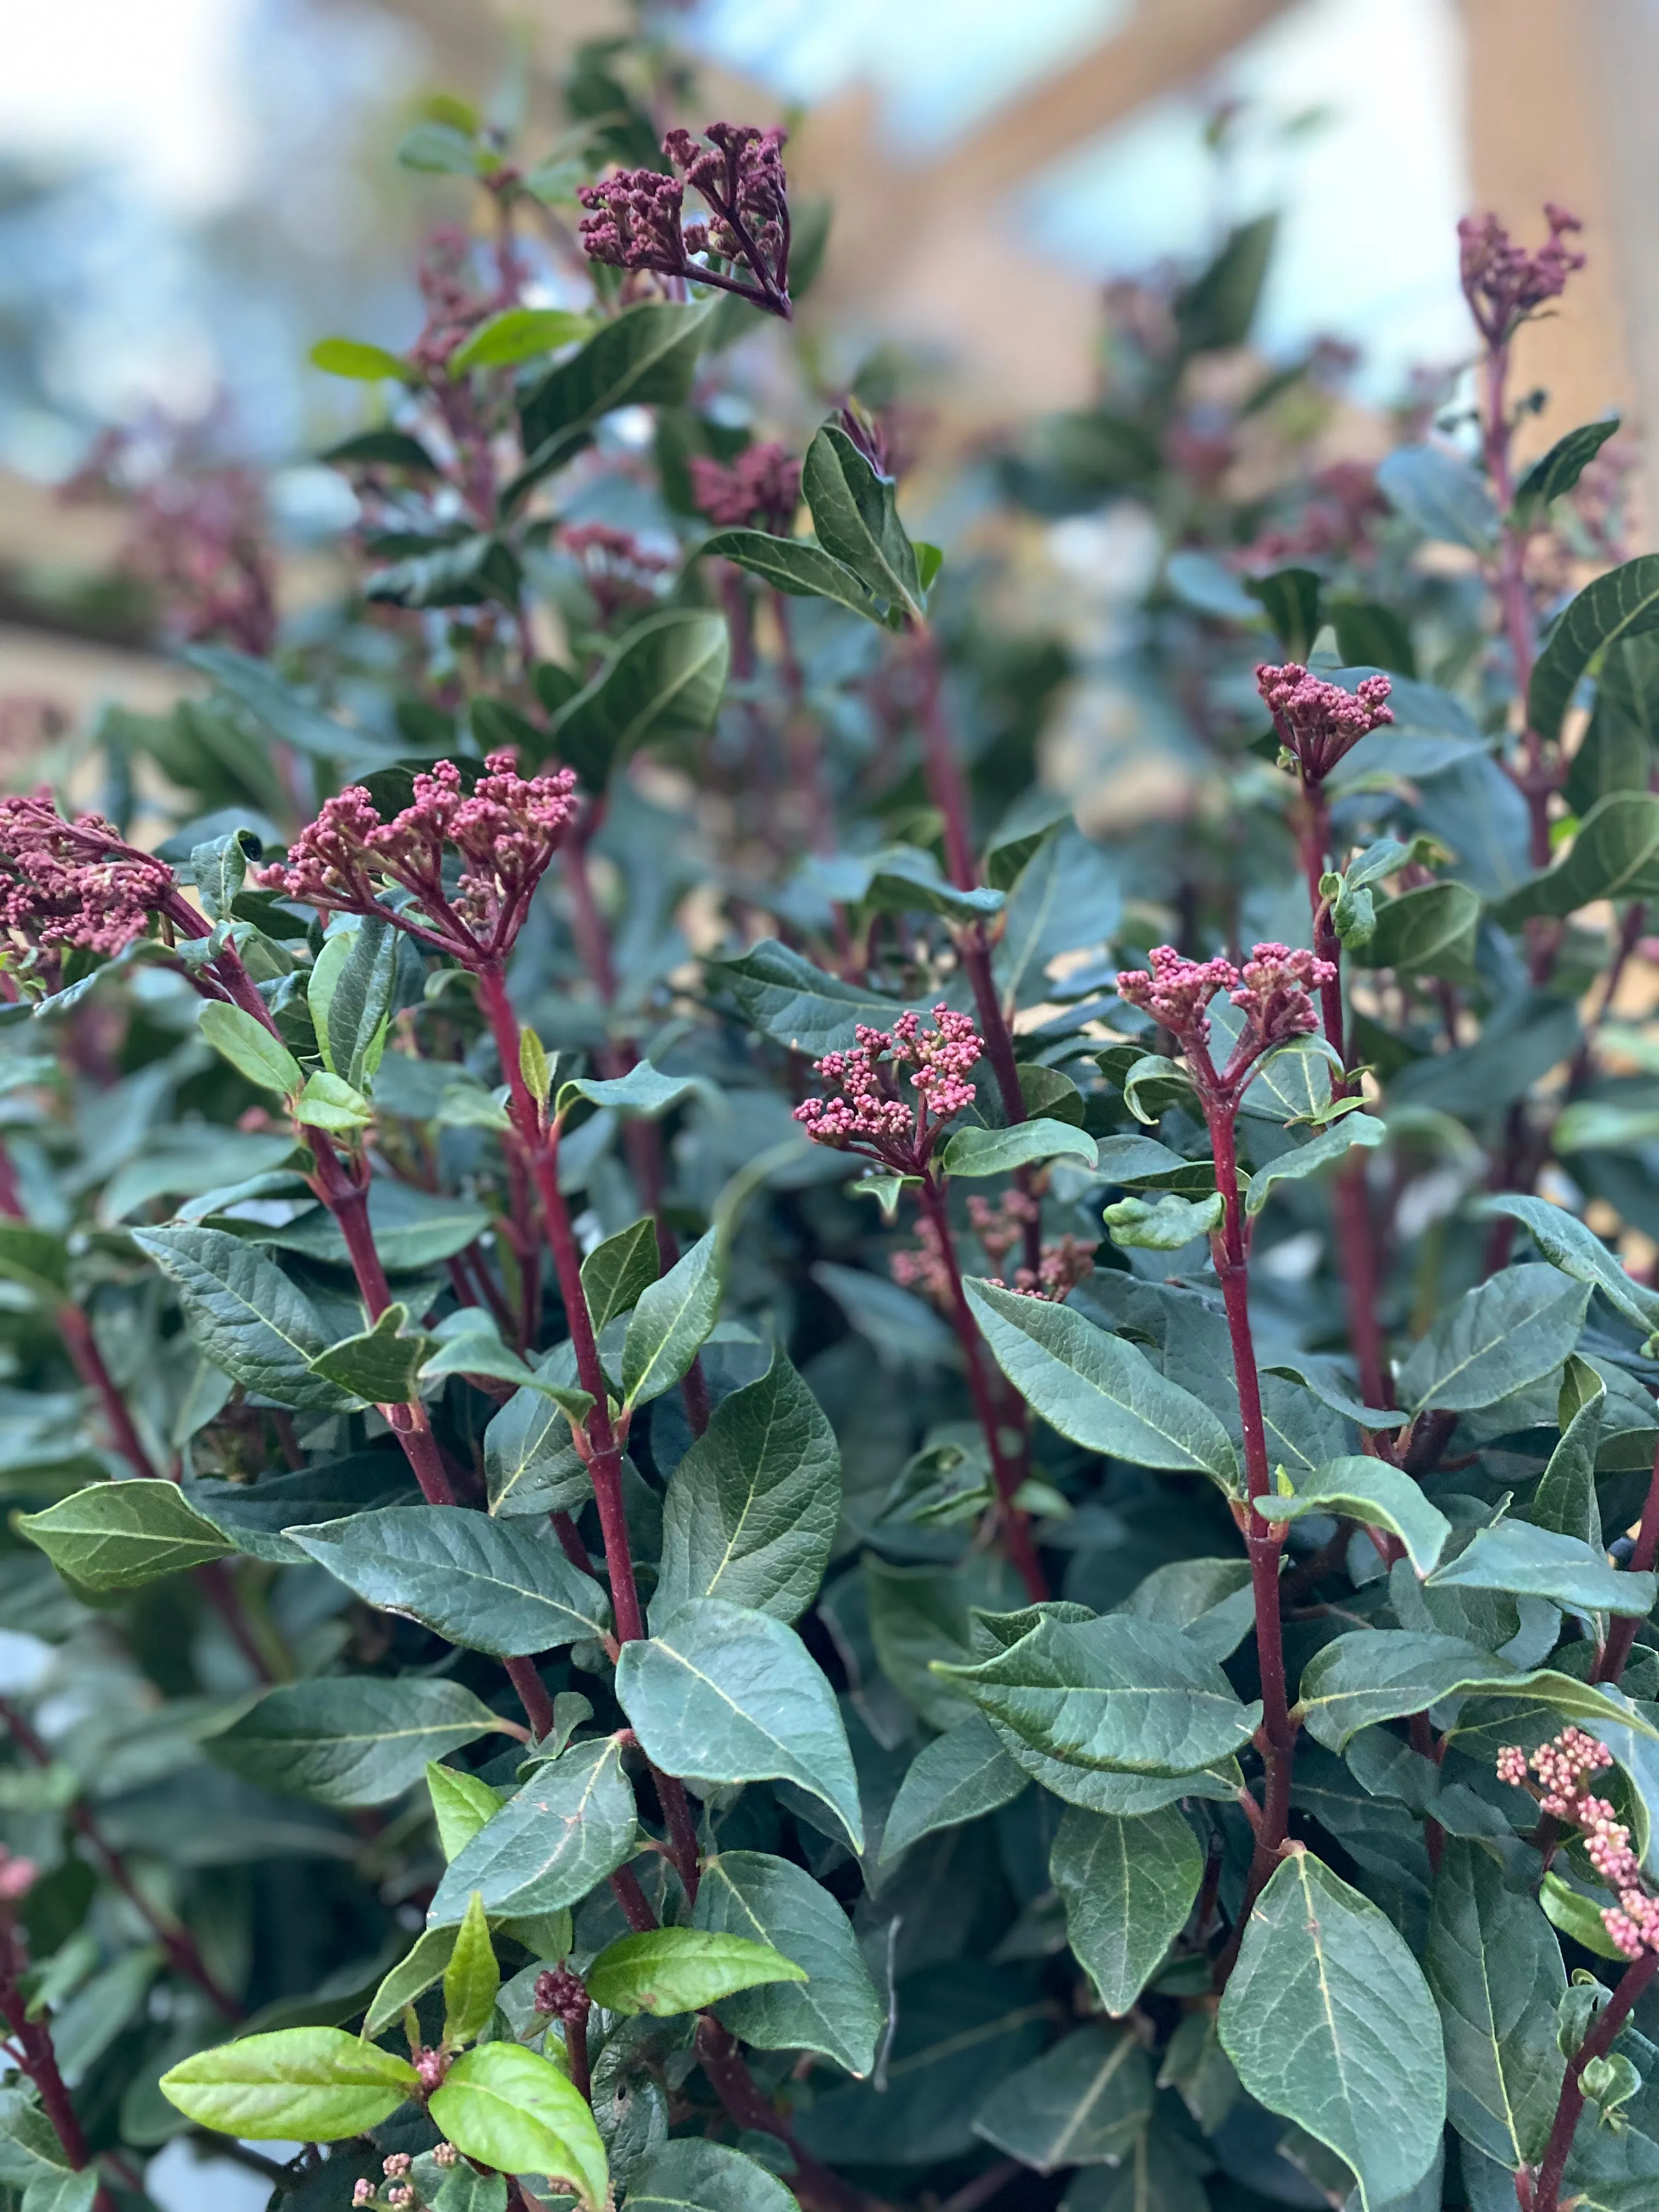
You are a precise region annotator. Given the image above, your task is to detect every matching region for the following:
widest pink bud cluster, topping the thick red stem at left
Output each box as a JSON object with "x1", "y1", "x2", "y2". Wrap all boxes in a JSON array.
[{"x1": 255, "y1": 752, "x2": 575, "y2": 967}]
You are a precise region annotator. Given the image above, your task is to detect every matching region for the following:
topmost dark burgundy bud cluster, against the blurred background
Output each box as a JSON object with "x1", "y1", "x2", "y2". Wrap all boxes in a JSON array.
[{"x1": 577, "y1": 124, "x2": 789, "y2": 321}]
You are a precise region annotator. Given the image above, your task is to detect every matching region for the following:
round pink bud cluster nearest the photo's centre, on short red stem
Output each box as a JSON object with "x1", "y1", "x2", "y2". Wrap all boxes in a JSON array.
[{"x1": 794, "y1": 1005, "x2": 984, "y2": 1175}]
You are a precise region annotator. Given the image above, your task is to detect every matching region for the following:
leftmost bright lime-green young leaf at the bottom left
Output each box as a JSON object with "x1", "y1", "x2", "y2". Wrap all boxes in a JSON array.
[{"x1": 161, "y1": 2028, "x2": 420, "y2": 2143}]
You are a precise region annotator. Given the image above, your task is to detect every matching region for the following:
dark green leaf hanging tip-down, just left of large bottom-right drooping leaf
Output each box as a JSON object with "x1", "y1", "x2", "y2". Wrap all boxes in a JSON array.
[{"x1": 1048, "y1": 1805, "x2": 1203, "y2": 2017}]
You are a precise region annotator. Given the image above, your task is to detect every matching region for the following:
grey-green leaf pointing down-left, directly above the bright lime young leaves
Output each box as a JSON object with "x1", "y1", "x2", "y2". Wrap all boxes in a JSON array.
[{"x1": 427, "y1": 1739, "x2": 635, "y2": 1927}]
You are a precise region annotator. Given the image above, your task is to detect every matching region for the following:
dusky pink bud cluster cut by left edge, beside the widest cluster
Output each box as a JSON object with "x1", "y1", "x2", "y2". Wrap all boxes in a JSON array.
[{"x1": 0, "y1": 787, "x2": 180, "y2": 953}]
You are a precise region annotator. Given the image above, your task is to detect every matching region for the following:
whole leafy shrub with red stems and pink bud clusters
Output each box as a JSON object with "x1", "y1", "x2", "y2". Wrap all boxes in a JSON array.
[{"x1": 13, "y1": 30, "x2": 1659, "y2": 2212}]
